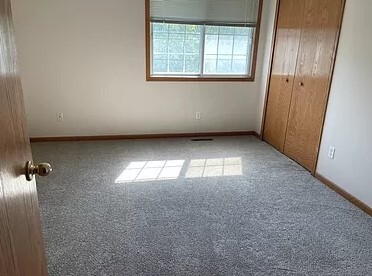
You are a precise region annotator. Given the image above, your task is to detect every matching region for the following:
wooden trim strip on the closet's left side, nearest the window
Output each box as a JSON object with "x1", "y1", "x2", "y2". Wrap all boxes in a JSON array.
[{"x1": 260, "y1": 0, "x2": 281, "y2": 140}]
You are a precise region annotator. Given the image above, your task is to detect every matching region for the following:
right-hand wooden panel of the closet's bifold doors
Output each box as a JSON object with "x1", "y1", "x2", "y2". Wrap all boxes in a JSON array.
[{"x1": 284, "y1": 0, "x2": 344, "y2": 171}]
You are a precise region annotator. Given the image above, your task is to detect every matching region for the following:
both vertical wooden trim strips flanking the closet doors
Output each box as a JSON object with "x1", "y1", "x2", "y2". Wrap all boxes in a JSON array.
[{"x1": 259, "y1": 0, "x2": 346, "y2": 176}]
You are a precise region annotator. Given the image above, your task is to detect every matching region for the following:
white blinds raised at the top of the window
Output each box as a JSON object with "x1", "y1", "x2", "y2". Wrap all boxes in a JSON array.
[{"x1": 150, "y1": 0, "x2": 259, "y2": 27}]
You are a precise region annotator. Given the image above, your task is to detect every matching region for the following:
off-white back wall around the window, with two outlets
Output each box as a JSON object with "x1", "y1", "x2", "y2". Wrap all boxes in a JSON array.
[{"x1": 12, "y1": 0, "x2": 274, "y2": 137}]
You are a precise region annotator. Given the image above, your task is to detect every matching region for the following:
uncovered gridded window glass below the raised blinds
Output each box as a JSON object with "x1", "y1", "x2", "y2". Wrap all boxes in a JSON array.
[{"x1": 152, "y1": 23, "x2": 254, "y2": 77}]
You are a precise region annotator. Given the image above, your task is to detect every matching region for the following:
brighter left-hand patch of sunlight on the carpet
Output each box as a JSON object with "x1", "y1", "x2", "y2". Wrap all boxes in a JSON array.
[{"x1": 115, "y1": 160, "x2": 185, "y2": 183}]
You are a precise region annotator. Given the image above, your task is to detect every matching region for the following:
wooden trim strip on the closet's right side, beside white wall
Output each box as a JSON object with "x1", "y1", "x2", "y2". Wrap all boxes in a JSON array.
[{"x1": 311, "y1": 0, "x2": 346, "y2": 176}]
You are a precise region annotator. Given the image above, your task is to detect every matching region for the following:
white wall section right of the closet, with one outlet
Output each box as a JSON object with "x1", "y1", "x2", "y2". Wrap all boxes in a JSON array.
[{"x1": 317, "y1": 0, "x2": 372, "y2": 207}]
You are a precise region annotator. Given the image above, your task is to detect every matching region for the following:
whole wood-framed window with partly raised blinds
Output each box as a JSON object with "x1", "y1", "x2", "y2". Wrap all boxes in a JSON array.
[{"x1": 146, "y1": 0, "x2": 262, "y2": 81}]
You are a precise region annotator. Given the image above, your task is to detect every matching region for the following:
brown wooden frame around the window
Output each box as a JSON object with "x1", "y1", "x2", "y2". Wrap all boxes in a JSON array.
[{"x1": 145, "y1": 0, "x2": 263, "y2": 82}]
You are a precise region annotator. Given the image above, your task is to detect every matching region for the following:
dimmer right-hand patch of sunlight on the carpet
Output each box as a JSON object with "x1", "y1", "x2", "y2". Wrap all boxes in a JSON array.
[{"x1": 186, "y1": 157, "x2": 243, "y2": 178}]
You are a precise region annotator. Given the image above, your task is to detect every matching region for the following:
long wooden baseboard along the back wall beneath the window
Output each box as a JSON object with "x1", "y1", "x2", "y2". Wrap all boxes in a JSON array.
[{"x1": 30, "y1": 131, "x2": 259, "y2": 143}]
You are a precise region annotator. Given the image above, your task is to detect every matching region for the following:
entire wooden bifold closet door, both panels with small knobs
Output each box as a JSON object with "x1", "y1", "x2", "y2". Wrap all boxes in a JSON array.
[{"x1": 263, "y1": 0, "x2": 345, "y2": 172}]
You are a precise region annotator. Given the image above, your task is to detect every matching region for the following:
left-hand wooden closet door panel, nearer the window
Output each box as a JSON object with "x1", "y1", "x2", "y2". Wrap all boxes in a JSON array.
[{"x1": 263, "y1": 0, "x2": 306, "y2": 151}]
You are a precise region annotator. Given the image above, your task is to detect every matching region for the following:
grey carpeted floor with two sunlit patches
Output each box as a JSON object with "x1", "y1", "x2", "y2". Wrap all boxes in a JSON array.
[{"x1": 32, "y1": 137, "x2": 372, "y2": 276}]
